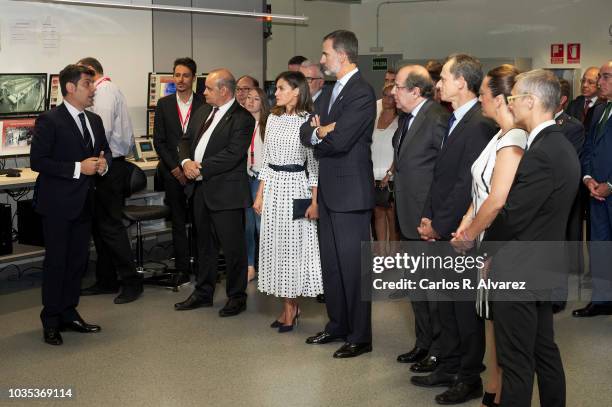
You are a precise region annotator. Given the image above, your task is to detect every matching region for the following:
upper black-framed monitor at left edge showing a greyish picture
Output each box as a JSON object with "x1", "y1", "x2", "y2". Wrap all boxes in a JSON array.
[{"x1": 0, "y1": 73, "x2": 47, "y2": 116}]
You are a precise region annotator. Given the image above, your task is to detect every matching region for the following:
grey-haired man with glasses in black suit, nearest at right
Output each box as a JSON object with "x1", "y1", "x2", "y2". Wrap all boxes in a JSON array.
[{"x1": 484, "y1": 69, "x2": 580, "y2": 407}]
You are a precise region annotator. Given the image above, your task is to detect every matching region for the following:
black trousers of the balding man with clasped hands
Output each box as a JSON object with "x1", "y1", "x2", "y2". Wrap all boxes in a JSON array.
[{"x1": 193, "y1": 184, "x2": 247, "y2": 299}]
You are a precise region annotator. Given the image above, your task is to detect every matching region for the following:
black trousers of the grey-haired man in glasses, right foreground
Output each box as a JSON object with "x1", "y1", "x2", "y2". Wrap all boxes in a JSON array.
[{"x1": 493, "y1": 301, "x2": 565, "y2": 407}]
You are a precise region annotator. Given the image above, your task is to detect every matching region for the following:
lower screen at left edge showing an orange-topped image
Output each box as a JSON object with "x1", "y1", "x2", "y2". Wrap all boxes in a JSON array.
[{"x1": 0, "y1": 116, "x2": 36, "y2": 157}]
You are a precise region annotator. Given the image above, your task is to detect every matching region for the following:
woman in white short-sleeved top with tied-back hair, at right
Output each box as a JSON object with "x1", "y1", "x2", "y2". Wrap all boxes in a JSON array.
[{"x1": 451, "y1": 65, "x2": 527, "y2": 407}]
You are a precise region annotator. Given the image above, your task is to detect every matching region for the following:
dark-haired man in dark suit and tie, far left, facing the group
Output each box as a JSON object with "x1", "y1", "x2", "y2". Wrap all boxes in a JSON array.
[{"x1": 30, "y1": 65, "x2": 112, "y2": 345}]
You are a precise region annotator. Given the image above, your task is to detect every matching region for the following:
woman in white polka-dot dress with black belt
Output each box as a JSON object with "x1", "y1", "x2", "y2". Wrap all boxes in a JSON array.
[{"x1": 253, "y1": 71, "x2": 323, "y2": 333}]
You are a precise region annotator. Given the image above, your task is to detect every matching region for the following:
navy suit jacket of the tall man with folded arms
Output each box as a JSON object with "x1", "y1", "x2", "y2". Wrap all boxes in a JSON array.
[{"x1": 300, "y1": 72, "x2": 376, "y2": 212}]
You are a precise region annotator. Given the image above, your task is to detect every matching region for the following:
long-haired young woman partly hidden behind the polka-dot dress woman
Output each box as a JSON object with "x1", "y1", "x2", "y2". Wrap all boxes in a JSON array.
[{"x1": 244, "y1": 88, "x2": 270, "y2": 281}]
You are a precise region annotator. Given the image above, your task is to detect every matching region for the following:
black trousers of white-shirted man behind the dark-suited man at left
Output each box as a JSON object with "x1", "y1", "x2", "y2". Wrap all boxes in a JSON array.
[{"x1": 93, "y1": 159, "x2": 142, "y2": 288}]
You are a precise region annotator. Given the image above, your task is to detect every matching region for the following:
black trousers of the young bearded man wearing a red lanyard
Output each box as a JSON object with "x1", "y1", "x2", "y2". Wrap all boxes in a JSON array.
[{"x1": 160, "y1": 169, "x2": 189, "y2": 273}]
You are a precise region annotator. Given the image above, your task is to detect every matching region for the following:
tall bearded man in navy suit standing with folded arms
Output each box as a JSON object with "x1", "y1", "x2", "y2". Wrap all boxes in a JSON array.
[{"x1": 301, "y1": 30, "x2": 376, "y2": 358}]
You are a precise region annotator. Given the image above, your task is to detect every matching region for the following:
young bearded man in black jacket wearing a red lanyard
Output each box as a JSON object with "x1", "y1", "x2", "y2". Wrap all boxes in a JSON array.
[{"x1": 153, "y1": 58, "x2": 204, "y2": 283}]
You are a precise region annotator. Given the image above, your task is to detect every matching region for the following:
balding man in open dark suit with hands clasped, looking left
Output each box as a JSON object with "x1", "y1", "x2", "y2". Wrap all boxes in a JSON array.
[{"x1": 174, "y1": 69, "x2": 255, "y2": 317}]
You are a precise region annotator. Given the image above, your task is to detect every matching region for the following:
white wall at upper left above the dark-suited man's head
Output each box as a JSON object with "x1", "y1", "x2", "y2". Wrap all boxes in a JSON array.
[{"x1": 0, "y1": 0, "x2": 153, "y2": 135}]
